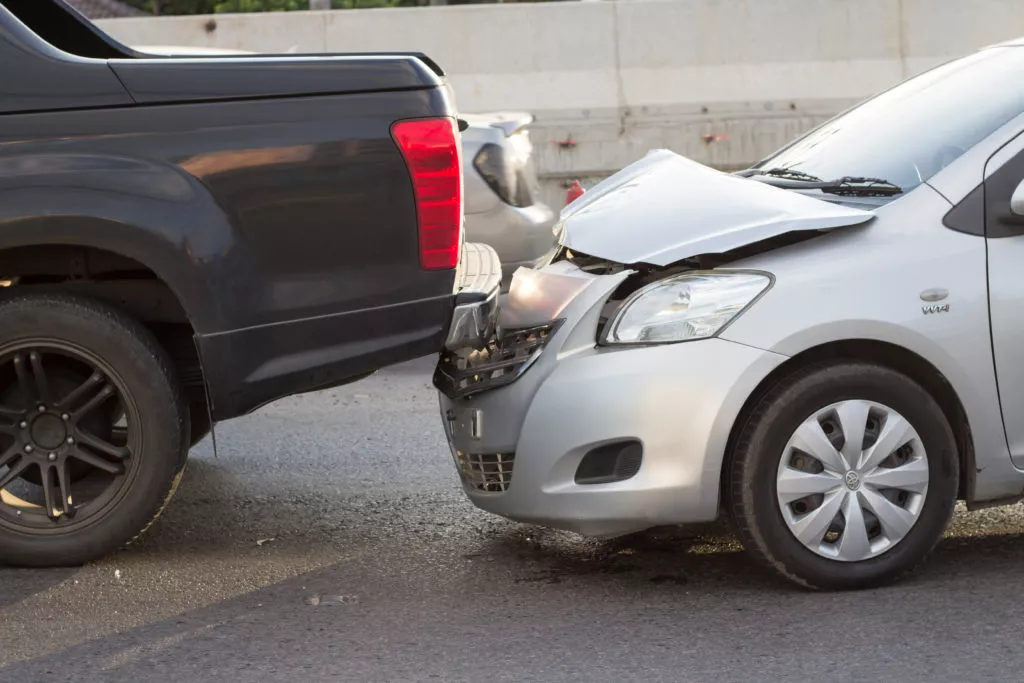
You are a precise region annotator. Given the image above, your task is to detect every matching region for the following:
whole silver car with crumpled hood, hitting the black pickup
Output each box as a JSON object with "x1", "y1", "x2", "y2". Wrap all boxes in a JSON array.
[{"x1": 435, "y1": 41, "x2": 1024, "y2": 589}]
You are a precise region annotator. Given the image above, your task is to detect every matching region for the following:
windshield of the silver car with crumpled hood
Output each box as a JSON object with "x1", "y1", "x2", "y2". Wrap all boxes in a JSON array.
[{"x1": 754, "y1": 47, "x2": 1024, "y2": 191}]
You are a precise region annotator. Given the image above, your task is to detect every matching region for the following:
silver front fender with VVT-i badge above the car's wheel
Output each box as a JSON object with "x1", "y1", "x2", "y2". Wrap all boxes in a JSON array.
[{"x1": 722, "y1": 185, "x2": 1024, "y2": 500}]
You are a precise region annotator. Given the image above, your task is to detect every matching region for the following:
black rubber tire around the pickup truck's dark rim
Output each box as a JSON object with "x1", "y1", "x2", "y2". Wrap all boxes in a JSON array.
[{"x1": 0, "y1": 295, "x2": 189, "y2": 567}]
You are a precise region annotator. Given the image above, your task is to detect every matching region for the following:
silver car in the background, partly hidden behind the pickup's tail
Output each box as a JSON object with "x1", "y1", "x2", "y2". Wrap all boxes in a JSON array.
[{"x1": 462, "y1": 112, "x2": 556, "y2": 288}]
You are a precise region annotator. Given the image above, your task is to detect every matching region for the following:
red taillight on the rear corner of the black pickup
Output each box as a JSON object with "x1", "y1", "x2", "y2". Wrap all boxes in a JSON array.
[{"x1": 391, "y1": 119, "x2": 462, "y2": 270}]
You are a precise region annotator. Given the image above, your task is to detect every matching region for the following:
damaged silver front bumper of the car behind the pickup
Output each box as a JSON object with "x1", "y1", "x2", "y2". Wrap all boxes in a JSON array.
[{"x1": 434, "y1": 261, "x2": 784, "y2": 537}]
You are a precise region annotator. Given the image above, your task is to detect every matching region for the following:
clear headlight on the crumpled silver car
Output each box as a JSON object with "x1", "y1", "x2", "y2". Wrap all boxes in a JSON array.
[{"x1": 604, "y1": 271, "x2": 771, "y2": 344}]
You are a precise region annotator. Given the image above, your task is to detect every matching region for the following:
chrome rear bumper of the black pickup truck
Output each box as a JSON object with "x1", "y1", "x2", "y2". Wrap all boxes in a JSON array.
[{"x1": 444, "y1": 243, "x2": 502, "y2": 350}]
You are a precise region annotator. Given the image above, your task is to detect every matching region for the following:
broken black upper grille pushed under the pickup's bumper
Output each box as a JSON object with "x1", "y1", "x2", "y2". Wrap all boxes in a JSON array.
[{"x1": 434, "y1": 319, "x2": 562, "y2": 398}]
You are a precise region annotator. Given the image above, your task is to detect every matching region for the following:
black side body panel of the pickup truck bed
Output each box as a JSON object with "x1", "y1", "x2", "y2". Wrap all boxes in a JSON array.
[{"x1": 0, "y1": 7, "x2": 455, "y2": 419}]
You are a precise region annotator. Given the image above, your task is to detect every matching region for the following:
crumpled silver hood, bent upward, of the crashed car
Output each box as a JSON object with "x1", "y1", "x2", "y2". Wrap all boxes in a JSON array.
[{"x1": 555, "y1": 150, "x2": 874, "y2": 266}]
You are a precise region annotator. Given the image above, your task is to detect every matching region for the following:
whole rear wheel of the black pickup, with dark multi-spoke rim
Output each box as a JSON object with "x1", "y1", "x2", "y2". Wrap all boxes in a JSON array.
[{"x1": 0, "y1": 295, "x2": 189, "y2": 566}]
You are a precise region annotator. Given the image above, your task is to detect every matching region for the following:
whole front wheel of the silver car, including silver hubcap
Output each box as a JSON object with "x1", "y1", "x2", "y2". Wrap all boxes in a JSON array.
[{"x1": 727, "y1": 362, "x2": 958, "y2": 590}]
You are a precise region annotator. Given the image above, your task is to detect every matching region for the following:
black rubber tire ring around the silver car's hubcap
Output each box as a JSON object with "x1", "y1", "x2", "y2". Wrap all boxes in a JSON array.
[{"x1": 725, "y1": 362, "x2": 958, "y2": 590}]
